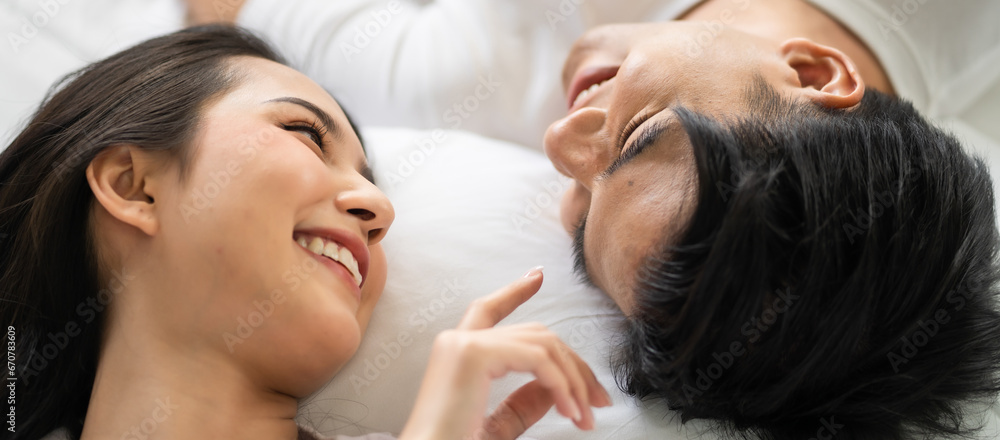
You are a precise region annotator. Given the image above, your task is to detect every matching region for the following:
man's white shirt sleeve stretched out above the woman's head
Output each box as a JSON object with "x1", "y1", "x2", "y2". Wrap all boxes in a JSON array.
[{"x1": 239, "y1": 0, "x2": 697, "y2": 148}]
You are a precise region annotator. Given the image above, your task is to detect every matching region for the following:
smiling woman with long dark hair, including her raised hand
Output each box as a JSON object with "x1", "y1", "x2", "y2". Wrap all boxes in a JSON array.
[{"x1": 0, "y1": 27, "x2": 610, "y2": 439}]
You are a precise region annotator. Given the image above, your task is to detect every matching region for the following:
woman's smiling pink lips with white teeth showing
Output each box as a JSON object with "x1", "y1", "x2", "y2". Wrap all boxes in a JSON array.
[{"x1": 292, "y1": 228, "x2": 370, "y2": 299}]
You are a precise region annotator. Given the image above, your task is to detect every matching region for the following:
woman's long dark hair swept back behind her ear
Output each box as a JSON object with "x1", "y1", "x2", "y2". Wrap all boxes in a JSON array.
[{"x1": 0, "y1": 26, "x2": 284, "y2": 439}]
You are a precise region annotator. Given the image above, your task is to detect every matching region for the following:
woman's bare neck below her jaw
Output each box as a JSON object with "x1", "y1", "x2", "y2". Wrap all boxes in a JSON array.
[{"x1": 82, "y1": 292, "x2": 297, "y2": 440}]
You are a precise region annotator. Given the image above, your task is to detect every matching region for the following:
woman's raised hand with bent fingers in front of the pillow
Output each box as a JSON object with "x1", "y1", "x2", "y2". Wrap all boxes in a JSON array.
[{"x1": 400, "y1": 268, "x2": 611, "y2": 440}]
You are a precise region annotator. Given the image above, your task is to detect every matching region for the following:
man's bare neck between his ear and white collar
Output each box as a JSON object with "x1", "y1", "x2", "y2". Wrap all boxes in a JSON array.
[{"x1": 681, "y1": 0, "x2": 895, "y2": 94}]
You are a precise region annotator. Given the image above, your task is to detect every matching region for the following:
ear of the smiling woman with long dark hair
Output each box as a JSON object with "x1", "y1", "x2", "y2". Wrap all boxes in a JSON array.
[{"x1": 87, "y1": 145, "x2": 159, "y2": 235}]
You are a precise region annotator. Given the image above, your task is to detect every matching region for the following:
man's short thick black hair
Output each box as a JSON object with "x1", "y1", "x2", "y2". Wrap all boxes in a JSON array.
[{"x1": 615, "y1": 79, "x2": 1000, "y2": 440}]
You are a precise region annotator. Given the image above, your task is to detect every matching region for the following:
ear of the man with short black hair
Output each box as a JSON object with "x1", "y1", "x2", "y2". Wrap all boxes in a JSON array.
[{"x1": 781, "y1": 38, "x2": 865, "y2": 108}]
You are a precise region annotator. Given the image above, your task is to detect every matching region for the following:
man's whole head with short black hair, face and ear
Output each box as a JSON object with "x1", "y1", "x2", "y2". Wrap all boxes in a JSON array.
[{"x1": 545, "y1": 11, "x2": 1000, "y2": 439}]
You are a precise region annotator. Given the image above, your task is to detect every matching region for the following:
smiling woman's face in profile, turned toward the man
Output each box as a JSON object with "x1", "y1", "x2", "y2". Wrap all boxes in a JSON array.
[{"x1": 132, "y1": 57, "x2": 394, "y2": 396}]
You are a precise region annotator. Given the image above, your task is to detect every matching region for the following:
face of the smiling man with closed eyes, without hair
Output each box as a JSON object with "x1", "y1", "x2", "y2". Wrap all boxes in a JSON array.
[{"x1": 544, "y1": 22, "x2": 802, "y2": 314}]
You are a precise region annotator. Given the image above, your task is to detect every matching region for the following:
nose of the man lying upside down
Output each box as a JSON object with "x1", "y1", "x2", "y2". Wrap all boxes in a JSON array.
[{"x1": 544, "y1": 107, "x2": 615, "y2": 189}]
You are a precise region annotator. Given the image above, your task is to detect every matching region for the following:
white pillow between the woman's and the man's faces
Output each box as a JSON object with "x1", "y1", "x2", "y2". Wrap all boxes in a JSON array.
[{"x1": 292, "y1": 129, "x2": 711, "y2": 439}]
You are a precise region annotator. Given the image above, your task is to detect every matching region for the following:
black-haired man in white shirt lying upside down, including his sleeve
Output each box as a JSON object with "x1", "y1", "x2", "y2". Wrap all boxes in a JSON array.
[{"x1": 192, "y1": 0, "x2": 1000, "y2": 439}]
